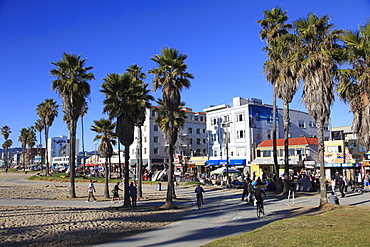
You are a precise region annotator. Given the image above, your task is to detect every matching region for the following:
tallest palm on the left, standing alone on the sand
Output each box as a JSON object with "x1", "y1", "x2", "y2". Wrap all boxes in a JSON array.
[{"x1": 50, "y1": 53, "x2": 95, "y2": 198}]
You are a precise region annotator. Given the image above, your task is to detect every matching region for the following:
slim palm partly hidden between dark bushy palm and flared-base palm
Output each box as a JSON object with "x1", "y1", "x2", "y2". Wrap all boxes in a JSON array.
[{"x1": 126, "y1": 64, "x2": 154, "y2": 197}]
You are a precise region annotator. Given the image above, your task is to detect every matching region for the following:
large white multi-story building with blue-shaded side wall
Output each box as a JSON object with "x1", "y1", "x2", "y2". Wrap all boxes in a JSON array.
[{"x1": 204, "y1": 97, "x2": 330, "y2": 173}]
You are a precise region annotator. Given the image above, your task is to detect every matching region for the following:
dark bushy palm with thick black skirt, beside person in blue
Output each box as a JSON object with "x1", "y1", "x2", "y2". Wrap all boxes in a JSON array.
[{"x1": 100, "y1": 73, "x2": 150, "y2": 207}]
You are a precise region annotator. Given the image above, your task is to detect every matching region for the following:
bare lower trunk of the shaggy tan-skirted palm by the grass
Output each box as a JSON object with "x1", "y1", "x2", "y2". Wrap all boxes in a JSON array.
[{"x1": 317, "y1": 120, "x2": 328, "y2": 206}]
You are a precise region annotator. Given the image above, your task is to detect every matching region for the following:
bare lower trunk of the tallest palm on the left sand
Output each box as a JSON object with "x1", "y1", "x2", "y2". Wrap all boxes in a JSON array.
[{"x1": 69, "y1": 120, "x2": 77, "y2": 198}]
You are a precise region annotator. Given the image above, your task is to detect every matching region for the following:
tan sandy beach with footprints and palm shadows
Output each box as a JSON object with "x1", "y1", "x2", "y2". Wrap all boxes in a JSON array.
[{"x1": 0, "y1": 172, "x2": 191, "y2": 246}]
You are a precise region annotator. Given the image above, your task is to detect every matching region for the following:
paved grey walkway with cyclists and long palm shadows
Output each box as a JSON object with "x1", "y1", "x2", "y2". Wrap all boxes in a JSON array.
[{"x1": 0, "y1": 175, "x2": 370, "y2": 247}]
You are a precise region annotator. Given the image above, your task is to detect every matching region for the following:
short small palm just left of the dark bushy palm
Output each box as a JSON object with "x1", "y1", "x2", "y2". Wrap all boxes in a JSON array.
[{"x1": 91, "y1": 118, "x2": 117, "y2": 198}]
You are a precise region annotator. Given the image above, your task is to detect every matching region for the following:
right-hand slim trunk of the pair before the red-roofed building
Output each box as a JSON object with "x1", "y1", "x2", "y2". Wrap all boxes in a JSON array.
[{"x1": 283, "y1": 101, "x2": 290, "y2": 194}]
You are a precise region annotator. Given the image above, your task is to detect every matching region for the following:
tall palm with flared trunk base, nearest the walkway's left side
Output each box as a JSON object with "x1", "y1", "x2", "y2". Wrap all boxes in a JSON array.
[{"x1": 148, "y1": 48, "x2": 194, "y2": 208}]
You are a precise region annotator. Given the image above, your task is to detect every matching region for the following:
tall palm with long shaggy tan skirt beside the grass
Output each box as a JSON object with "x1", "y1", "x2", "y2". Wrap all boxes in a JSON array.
[{"x1": 293, "y1": 14, "x2": 342, "y2": 205}]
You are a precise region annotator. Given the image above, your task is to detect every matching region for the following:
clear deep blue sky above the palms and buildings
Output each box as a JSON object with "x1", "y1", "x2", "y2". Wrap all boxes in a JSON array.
[{"x1": 0, "y1": 0, "x2": 370, "y2": 150}]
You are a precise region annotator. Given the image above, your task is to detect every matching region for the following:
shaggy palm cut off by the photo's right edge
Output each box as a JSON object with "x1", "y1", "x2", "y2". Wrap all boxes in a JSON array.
[{"x1": 337, "y1": 21, "x2": 370, "y2": 150}]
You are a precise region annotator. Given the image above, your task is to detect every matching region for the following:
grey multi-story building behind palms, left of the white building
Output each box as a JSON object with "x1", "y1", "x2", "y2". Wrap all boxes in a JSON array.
[{"x1": 130, "y1": 107, "x2": 207, "y2": 170}]
